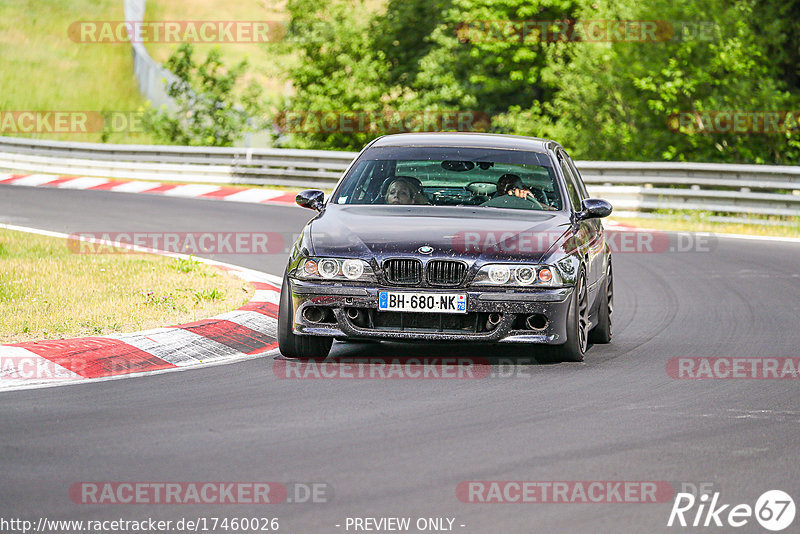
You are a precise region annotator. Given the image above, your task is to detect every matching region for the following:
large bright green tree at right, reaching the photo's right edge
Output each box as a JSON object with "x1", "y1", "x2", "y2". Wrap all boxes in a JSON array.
[{"x1": 495, "y1": 0, "x2": 800, "y2": 163}]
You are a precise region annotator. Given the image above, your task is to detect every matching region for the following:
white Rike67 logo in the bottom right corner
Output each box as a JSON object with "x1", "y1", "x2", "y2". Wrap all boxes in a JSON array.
[{"x1": 667, "y1": 490, "x2": 795, "y2": 532}]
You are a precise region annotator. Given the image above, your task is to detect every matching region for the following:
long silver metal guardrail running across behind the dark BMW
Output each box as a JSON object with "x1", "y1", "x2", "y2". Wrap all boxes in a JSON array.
[{"x1": 0, "y1": 137, "x2": 800, "y2": 222}]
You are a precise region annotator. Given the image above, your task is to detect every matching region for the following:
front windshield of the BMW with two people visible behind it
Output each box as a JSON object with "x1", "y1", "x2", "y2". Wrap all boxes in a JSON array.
[{"x1": 332, "y1": 147, "x2": 563, "y2": 214}]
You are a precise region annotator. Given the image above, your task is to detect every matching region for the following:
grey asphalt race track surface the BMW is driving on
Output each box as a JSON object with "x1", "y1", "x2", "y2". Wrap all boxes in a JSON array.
[{"x1": 0, "y1": 186, "x2": 800, "y2": 534}]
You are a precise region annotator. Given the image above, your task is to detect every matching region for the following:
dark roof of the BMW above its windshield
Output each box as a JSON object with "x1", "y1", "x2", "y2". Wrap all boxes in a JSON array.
[{"x1": 370, "y1": 132, "x2": 559, "y2": 152}]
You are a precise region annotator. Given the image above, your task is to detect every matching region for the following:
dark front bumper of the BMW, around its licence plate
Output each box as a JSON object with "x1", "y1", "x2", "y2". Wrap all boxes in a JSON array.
[{"x1": 289, "y1": 278, "x2": 573, "y2": 345}]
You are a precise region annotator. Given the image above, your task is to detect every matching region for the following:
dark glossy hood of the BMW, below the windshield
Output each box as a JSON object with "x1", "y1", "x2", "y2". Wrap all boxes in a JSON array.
[{"x1": 310, "y1": 205, "x2": 570, "y2": 262}]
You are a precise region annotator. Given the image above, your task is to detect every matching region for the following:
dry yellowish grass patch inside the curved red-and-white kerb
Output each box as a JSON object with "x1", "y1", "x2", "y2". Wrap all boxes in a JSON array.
[{"x1": 0, "y1": 229, "x2": 253, "y2": 343}]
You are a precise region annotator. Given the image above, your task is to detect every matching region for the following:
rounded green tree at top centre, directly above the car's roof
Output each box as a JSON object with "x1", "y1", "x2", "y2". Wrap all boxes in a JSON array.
[{"x1": 411, "y1": 0, "x2": 576, "y2": 115}]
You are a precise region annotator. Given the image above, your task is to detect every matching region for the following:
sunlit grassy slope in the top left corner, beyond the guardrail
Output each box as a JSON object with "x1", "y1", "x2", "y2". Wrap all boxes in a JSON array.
[{"x1": 0, "y1": 0, "x2": 152, "y2": 144}]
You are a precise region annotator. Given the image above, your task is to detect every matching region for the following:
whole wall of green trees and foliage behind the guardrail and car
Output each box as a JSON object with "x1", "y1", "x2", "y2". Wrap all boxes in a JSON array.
[{"x1": 284, "y1": 0, "x2": 800, "y2": 164}]
